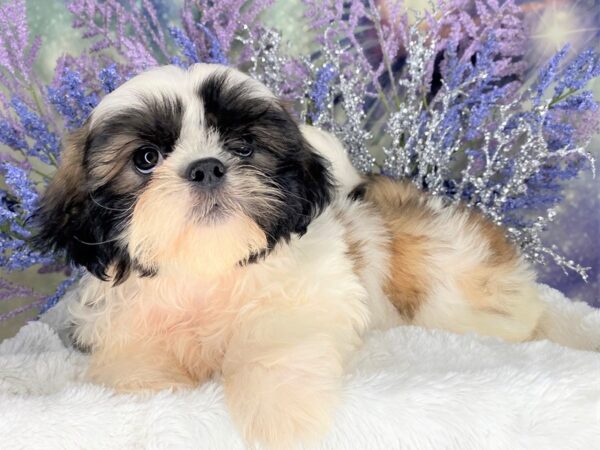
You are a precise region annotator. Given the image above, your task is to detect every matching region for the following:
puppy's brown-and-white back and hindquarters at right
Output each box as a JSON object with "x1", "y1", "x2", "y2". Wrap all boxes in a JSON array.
[{"x1": 355, "y1": 176, "x2": 542, "y2": 341}]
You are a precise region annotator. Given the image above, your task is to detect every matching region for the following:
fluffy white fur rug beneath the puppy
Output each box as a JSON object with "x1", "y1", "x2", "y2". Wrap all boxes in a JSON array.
[{"x1": 0, "y1": 287, "x2": 600, "y2": 450}]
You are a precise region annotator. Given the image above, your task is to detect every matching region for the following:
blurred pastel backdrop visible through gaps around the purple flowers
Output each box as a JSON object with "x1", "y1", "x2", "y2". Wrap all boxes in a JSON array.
[{"x1": 0, "y1": 0, "x2": 600, "y2": 338}]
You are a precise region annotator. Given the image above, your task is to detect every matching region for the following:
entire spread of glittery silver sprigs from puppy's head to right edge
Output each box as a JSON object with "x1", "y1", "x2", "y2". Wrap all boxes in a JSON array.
[{"x1": 243, "y1": 17, "x2": 593, "y2": 279}]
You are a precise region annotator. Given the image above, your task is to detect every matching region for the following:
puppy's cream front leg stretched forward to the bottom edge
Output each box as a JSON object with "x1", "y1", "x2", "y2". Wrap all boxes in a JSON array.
[{"x1": 223, "y1": 306, "x2": 360, "y2": 448}]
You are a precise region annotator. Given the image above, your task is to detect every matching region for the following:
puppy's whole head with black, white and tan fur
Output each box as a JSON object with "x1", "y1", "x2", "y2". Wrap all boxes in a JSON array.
[{"x1": 36, "y1": 65, "x2": 331, "y2": 281}]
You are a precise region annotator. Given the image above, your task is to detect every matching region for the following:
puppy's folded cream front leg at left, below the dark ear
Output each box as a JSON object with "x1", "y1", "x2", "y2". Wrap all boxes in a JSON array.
[{"x1": 66, "y1": 275, "x2": 203, "y2": 391}]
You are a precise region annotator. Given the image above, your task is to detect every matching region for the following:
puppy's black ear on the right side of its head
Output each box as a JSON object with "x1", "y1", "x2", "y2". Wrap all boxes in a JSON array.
[{"x1": 294, "y1": 138, "x2": 334, "y2": 234}]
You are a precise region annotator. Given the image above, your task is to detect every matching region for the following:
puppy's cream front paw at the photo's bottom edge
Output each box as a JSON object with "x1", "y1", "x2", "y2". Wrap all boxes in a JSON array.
[{"x1": 225, "y1": 361, "x2": 339, "y2": 449}]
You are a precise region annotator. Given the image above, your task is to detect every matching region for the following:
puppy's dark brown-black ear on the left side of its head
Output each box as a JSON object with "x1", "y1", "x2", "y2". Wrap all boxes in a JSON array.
[{"x1": 33, "y1": 124, "x2": 129, "y2": 282}]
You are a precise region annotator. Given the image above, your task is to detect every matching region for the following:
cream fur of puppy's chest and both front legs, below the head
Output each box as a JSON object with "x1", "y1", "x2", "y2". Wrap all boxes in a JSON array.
[{"x1": 72, "y1": 193, "x2": 399, "y2": 445}]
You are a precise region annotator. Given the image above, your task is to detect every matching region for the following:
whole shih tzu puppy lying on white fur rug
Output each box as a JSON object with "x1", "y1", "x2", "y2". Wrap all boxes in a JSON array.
[{"x1": 36, "y1": 65, "x2": 542, "y2": 448}]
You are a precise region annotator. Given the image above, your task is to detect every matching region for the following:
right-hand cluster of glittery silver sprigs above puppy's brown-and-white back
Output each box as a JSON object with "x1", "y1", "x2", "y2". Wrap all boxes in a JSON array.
[{"x1": 383, "y1": 28, "x2": 594, "y2": 279}]
